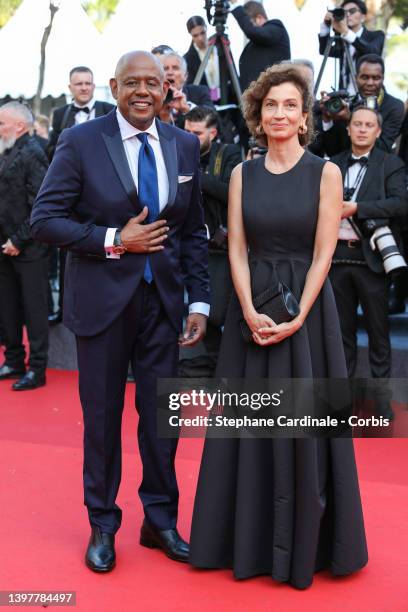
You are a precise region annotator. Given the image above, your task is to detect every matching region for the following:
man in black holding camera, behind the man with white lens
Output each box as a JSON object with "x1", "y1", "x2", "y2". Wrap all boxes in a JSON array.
[{"x1": 319, "y1": 55, "x2": 404, "y2": 157}]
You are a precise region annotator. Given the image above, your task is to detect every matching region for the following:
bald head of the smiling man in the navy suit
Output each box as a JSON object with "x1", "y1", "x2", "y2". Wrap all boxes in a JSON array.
[{"x1": 110, "y1": 51, "x2": 169, "y2": 131}]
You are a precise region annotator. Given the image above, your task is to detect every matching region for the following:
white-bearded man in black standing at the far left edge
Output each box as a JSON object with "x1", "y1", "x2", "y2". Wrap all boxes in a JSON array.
[{"x1": 0, "y1": 102, "x2": 48, "y2": 391}]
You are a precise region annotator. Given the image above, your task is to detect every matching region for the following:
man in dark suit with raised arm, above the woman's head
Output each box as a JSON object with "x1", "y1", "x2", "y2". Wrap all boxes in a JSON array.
[{"x1": 230, "y1": 0, "x2": 290, "y2": 91}]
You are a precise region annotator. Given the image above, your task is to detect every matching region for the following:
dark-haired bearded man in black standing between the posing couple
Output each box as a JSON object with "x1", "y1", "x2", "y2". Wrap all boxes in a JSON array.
[{"x1": 182, "y1": 106, "x2": 242, "y2": 377}]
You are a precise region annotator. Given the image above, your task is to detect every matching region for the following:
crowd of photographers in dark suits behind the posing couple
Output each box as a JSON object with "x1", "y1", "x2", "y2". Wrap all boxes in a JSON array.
[{"x1": 0, "y1": 0, "x2": 408, "y2": 390}]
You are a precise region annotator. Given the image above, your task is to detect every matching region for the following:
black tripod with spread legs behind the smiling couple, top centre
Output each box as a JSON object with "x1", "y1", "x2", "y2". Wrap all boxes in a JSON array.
[{"x1": 194, "y1": 24, "x2": 242, "y2": 105}]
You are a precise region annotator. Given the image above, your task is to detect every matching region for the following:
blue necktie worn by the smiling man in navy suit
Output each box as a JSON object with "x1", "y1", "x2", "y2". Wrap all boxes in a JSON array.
[{"x1": 137, "y1": 132, "x2": 160, "y2": 283}]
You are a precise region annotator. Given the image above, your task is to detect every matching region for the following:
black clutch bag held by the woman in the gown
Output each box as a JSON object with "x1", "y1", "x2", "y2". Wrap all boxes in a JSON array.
[{"x1": 240, "y1": 282, "x2": 300, "y2": 342}]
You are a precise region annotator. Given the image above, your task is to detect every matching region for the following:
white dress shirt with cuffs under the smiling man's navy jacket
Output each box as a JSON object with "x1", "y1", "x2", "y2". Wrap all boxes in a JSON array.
[{"x1": 104, "y1": 109, "x2": 210, "y2": 317}]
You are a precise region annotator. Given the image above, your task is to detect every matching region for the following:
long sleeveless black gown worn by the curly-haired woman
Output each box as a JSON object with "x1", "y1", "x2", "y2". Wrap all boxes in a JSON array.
[{"x1": 190, "y1": 151, "x2": 368, "y2": 588}]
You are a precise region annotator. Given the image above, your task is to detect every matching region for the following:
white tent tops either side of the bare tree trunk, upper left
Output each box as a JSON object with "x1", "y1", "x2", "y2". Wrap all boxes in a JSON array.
[{"x1": 0, "y1": 0, "x2": 108, "y2": 98}]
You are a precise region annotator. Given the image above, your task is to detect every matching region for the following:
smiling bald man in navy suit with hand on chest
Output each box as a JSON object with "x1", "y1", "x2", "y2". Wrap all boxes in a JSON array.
[{"x1": 31, "y1": 51, "x2": 209, "y2": 572}]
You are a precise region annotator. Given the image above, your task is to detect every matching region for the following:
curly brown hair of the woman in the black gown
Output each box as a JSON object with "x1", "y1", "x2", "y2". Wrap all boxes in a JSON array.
[{"x1": 242, "y1": 64, "x2": 313, "y2": 146}]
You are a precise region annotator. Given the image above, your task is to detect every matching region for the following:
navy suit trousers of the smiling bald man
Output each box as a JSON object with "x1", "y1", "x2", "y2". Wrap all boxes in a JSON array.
[{"x1": 77, "y1": 281, "x2": 179, "y2": 533}]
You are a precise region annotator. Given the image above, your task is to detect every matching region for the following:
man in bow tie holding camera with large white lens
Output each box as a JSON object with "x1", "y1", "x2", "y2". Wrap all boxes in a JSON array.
[{"x1": 330, "y1": 107, "x2": 408, "y2": 390}]
